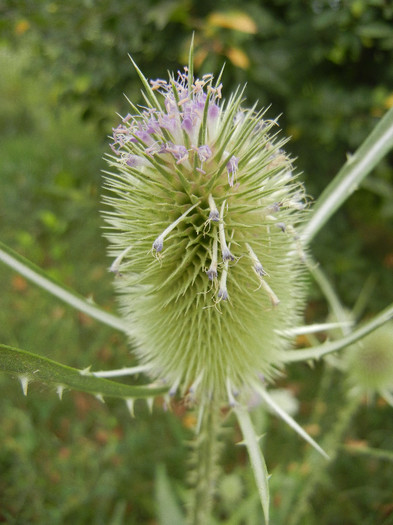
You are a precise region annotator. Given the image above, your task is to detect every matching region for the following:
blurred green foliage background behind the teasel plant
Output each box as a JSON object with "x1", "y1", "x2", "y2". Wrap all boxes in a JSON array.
[{"x1": 0, "y1": 0, "x2": 393, "y2": 525}]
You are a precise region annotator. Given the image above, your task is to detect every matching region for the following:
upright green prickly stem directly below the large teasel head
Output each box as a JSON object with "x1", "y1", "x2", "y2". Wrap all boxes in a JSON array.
[{"x1": 187, "y1": 402, "x2": 221, "y2": 525}]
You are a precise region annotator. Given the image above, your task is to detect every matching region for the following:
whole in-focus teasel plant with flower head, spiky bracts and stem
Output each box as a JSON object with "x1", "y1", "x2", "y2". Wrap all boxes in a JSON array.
[{"x1": 0, "y1": 42, "x2": 393, "y2": 524}]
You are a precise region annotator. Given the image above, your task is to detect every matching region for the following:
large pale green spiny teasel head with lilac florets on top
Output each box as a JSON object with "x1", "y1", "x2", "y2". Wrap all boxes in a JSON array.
[{"x1": 105, "y1": 57, "x2": 305, "y2": 402}]
